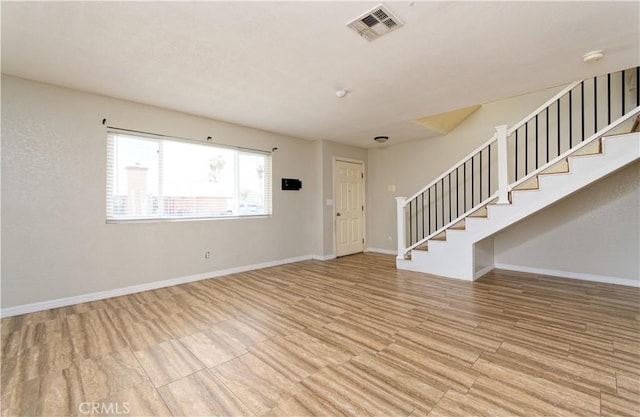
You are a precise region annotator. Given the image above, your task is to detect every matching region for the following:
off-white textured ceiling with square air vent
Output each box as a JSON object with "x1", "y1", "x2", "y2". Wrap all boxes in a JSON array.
[{"x1": 1, "y1": 2, "x2": 640, "y2": 147}]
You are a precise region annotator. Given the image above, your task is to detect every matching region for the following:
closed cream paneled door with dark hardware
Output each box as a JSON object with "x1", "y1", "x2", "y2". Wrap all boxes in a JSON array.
[{"x1": 334, "y1": 161, "x2": 364, "y2": 256}]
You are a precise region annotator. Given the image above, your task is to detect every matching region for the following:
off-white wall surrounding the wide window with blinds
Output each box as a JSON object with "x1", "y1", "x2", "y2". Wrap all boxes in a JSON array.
[{"x1": 1, "y1": 76, "x2": 321, "y2": 308}]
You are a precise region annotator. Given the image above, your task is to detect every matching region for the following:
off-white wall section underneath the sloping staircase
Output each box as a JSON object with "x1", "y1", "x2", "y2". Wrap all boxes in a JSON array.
[{"x1": 494, "y1": 162, "x2": 640, "y2": 282}]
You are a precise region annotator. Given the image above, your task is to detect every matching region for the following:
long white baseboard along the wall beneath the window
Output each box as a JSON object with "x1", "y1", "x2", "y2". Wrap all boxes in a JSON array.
[{"x1": 0, "y1": 255, "x2": 313, "y2": 318}]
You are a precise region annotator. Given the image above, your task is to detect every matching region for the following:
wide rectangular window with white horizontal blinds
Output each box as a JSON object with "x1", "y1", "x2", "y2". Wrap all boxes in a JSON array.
[{"x1": 107, "y1": 131, "x2": 271, "y2": 221}]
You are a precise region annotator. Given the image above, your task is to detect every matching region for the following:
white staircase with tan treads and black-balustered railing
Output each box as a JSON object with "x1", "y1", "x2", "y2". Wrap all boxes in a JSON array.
[{"x1": 396, "y1": 67, "x2": 640, "y2": 280}]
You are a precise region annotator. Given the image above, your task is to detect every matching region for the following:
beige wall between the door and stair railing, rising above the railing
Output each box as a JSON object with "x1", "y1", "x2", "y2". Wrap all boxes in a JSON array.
[{"x1": 367, "y1": 87, "x2": 561, "y2": 250}]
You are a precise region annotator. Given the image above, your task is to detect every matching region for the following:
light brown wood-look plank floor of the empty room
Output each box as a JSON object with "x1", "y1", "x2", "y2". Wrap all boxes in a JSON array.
[{"x1": 1, "y1": 254, "x2": 640, "y2": 417}]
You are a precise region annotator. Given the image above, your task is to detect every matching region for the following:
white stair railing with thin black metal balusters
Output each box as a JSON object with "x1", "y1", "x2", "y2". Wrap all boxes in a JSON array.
[{"x1": 396, "y1": 67, "x2": 640, "y2": 259}]
